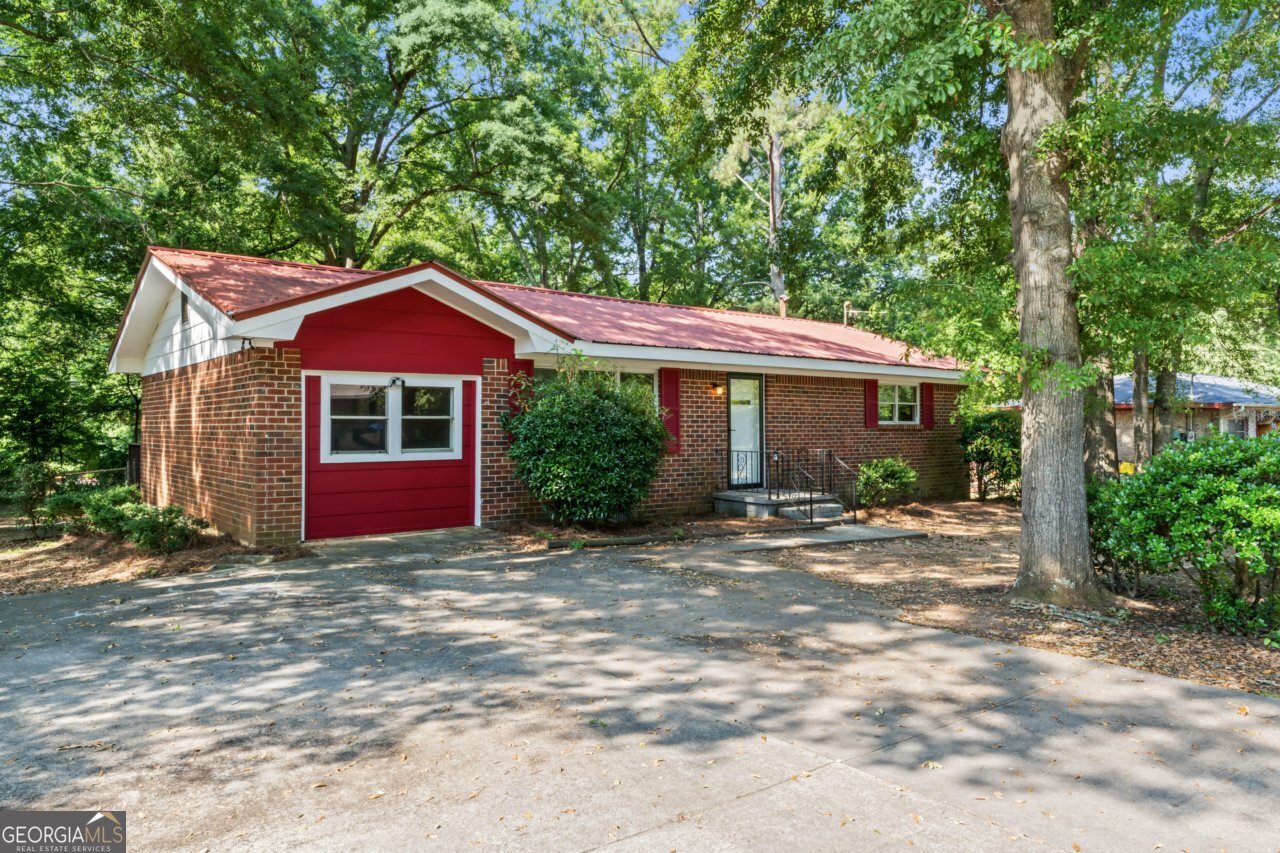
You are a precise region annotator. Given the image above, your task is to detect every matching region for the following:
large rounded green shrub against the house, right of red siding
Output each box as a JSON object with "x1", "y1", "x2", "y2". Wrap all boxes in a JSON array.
[{"x1": 503, "y1": 357, "x2": 669, "y2": 523}]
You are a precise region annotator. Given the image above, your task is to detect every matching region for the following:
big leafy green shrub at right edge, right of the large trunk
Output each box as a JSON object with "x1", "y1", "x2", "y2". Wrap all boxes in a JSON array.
[{"x1": 1089, "y1": 433, "x2": 1280, "y2": 634}]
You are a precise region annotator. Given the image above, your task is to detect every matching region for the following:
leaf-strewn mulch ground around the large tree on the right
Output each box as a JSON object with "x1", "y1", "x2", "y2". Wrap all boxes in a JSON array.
[{"x1": 774, "y1": 501, "x2": 1280, "y2": 695}]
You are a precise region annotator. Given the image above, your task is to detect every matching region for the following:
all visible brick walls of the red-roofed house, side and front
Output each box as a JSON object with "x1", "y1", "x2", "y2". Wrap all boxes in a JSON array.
[{"x1": 142, "y1": 350, "x2": 968, "y2": 544}]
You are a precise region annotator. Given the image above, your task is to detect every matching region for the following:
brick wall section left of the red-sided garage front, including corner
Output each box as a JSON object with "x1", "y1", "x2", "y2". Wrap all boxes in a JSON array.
[{"x1": 142, "y1": 348, "x2": 302, "y2": 544}]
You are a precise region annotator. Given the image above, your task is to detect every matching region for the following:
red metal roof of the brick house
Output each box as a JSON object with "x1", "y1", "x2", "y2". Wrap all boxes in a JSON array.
[{"x1": 148, "y1": 247, "x2": 959, "y2": 370}]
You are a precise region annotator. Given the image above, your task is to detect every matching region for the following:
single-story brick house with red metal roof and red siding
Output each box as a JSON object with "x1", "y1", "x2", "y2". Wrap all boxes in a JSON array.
[{"x1": 111, "y1": 247, "x2": 969, "y2": 543}]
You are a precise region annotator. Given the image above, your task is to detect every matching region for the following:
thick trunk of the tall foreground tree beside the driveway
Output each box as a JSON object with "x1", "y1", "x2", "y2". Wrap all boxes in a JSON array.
[{"x1": 1000, "y1": 0, "x2": 1106, "y2": 605}]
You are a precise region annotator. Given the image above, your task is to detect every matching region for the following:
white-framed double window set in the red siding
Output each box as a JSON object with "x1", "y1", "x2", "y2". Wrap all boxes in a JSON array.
[{"x1": 320, "y1": 374, "x2": 462, "y2": 462}]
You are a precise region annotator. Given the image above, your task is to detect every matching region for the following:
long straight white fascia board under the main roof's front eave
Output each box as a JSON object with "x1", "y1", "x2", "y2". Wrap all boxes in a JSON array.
[{"x1": 555, "y1": 341, "x2": 964, "y2": 384}]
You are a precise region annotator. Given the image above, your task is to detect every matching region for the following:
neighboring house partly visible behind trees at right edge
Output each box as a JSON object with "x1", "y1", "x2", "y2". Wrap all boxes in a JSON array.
[{"x1": 1115, "y1": 373, "x2": 1280, "y2": 462}]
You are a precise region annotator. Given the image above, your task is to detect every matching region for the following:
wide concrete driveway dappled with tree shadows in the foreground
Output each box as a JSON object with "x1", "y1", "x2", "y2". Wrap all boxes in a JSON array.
[{"x1": 0, "y1": 534, "x2": 1280, "y2": 850}]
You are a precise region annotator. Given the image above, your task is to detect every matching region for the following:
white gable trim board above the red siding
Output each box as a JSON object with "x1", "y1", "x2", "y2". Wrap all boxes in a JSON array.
[{"x1": 229, "y1": 269, "x2": 564, "y2": 351}]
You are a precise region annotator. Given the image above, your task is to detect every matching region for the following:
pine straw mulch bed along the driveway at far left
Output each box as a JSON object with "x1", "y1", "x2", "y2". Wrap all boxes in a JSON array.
[{"x1": 0, "y1": 529, "x2": 311, "y2": 596}]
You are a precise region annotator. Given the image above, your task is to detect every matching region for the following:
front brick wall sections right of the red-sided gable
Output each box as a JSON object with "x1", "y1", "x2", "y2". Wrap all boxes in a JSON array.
[{"x1": 481, "y1": 360, "x2": 969, "y2": 524}]
